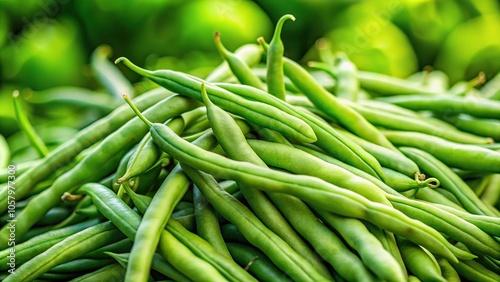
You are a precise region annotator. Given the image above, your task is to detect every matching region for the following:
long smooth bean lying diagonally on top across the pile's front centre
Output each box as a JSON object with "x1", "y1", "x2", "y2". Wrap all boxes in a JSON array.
[{"x1": 147, "y1": 124, "x2": 464, "y2": 261}]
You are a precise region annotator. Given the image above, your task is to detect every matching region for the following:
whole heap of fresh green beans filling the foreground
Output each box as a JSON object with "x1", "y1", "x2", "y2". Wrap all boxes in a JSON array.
[{"x1": 0, "y1": 15, "x2": 500, "y2": 282}]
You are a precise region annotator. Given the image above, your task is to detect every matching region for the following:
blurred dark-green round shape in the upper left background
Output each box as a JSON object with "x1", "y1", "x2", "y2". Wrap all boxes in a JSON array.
[{"x1": 0, "y1": 18, "x2": 86, "y2": 89}]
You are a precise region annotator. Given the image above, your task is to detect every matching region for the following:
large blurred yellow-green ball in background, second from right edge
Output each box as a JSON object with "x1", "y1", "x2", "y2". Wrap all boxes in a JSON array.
[{"x1": 325, "y1": 1, "x2": 418, "y2": 77}]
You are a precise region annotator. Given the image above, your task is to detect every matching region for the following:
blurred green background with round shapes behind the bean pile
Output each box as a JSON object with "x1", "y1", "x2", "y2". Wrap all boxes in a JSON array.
[{"x1": 0, "y1": 0, "x2": 500, "y2": 162}]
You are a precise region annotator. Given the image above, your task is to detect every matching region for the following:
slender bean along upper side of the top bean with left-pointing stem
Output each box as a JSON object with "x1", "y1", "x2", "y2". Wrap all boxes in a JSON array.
[{"x1": 217, "y1": 83, "x2": 383, "y2": 178}]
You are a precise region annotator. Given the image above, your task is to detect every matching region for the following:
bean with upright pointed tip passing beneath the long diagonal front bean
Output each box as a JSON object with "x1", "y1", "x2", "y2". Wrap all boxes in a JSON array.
[{"x1": 202, "y1": 85, "x2": 328, "y2": 275}]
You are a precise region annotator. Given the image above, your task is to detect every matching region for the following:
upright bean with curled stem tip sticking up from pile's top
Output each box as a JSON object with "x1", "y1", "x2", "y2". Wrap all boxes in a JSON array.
[{"x1": 265, "y1": 14, "x2": 295, "y2": 100}]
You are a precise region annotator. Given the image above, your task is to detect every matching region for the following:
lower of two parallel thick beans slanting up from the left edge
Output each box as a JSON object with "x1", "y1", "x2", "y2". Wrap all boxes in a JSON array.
[{"x1": 0, "y1": 93, "x2": 198, "y2": 246}]
